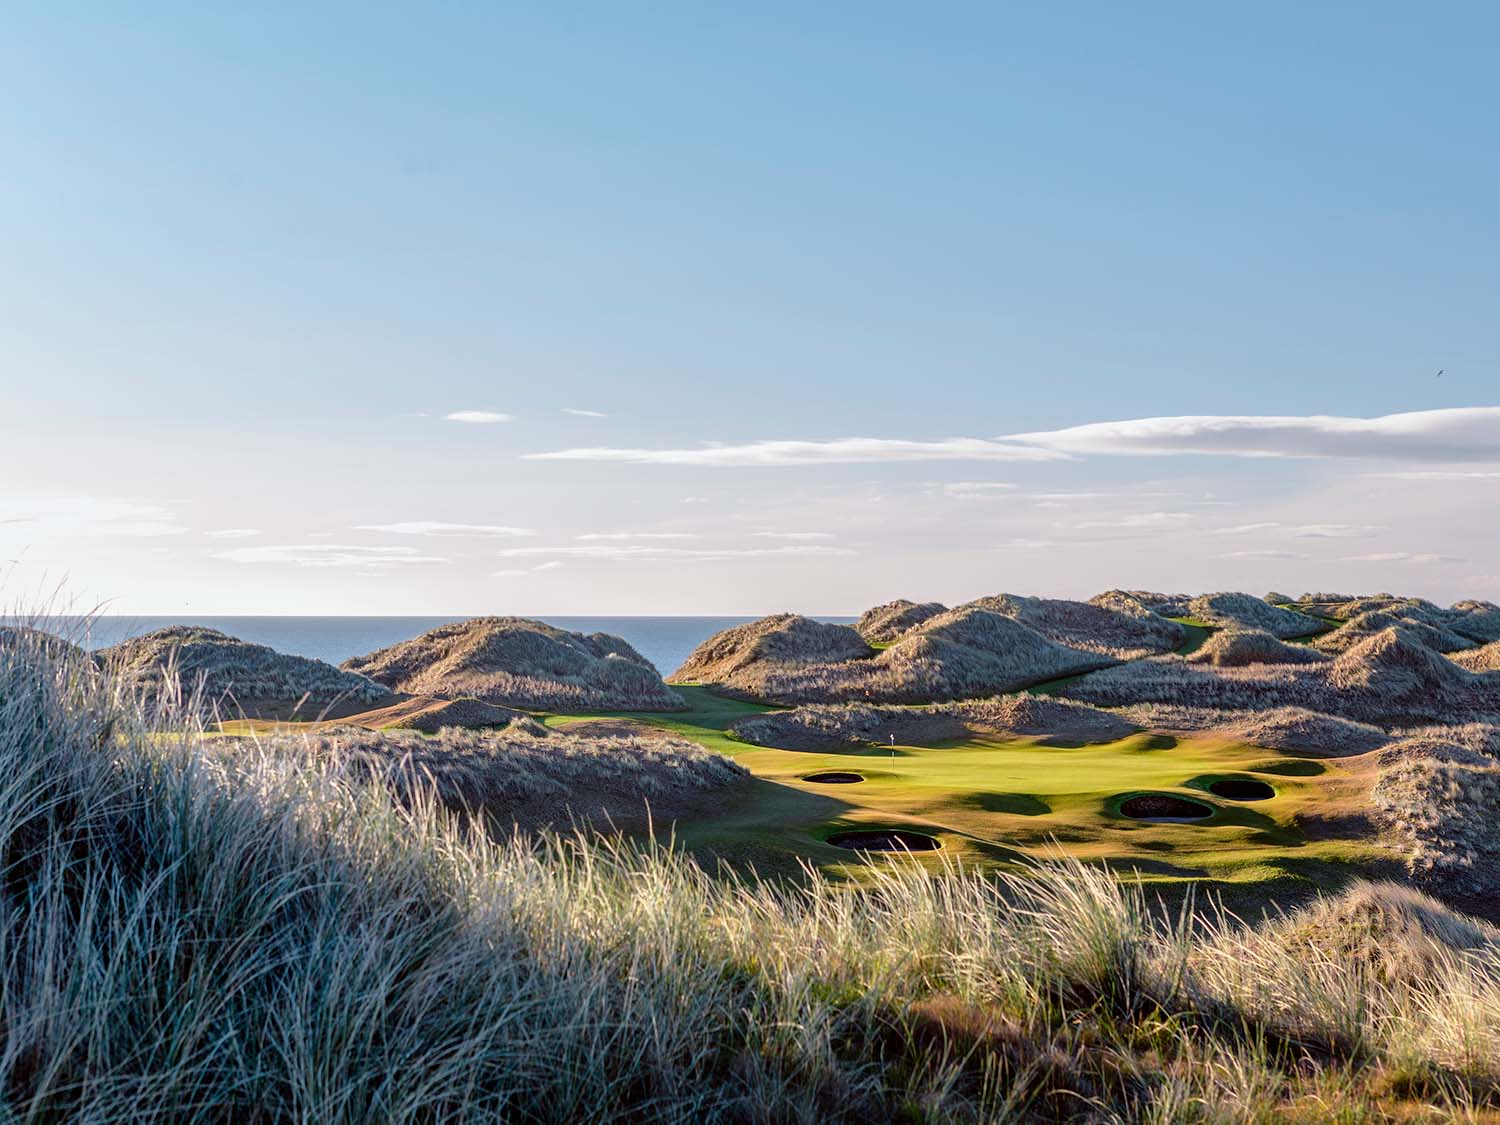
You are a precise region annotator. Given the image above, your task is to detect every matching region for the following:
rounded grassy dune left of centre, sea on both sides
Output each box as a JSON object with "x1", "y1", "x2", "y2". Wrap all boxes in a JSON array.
[{"x1": 342, "y1": 617, "x2": 686, "y2": 711}]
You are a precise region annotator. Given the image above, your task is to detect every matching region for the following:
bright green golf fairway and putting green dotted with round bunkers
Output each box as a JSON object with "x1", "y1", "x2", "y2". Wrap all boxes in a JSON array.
[{"x1": 548, "y1": 687, "x2": 1380, "y2": 885}]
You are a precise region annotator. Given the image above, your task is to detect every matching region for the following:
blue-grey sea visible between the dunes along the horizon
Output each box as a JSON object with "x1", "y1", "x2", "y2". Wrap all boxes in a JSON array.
[{"x1": 26, "y1": 615, "x2": 857, "y2": 675}]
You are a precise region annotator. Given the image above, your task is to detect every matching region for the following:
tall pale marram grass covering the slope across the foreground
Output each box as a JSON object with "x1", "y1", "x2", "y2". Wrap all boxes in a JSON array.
[{"x1": 0, "y1": 630, "x2": 1500, "y2": 1122}]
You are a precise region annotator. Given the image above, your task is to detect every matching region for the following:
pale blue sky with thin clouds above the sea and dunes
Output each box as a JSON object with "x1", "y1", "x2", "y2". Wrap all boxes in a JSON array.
[{"x1": 0, "y1": 0, "x2": 1500, "y2": 615}]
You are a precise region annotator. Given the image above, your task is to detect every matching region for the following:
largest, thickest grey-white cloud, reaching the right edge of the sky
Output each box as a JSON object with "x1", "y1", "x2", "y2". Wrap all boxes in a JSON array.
[{"x1": 996, "y1": 407, "x2": 1500, "y2": 461}]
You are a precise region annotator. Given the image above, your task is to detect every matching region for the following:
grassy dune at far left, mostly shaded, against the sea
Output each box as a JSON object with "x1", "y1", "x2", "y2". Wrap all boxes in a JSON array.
[{"x1": 98, "y1": 626, "x2": 390, "y2": 711}]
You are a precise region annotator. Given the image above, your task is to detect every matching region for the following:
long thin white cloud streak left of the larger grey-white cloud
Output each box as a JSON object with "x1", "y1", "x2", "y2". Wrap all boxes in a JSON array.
[{"x1": 522, "y1": 438, "x2": 1067, "y2": 468}]
